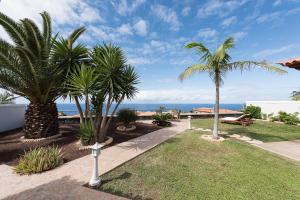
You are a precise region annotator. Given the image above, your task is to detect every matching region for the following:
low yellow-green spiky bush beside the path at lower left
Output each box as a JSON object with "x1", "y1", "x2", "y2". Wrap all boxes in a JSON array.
[{"x1": 15, "y1": 147, "x2": 63, "y2": 174}]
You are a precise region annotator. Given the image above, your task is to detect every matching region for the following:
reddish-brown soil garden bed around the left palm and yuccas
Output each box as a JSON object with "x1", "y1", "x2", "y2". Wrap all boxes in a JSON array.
[{"x1": 0, "y1": 123, "x2": 160, "y2": 166}]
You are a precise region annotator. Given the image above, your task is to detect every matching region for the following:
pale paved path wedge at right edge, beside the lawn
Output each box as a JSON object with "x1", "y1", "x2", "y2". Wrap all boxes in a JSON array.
[{"x1": 255, "y1": 140, "x2": 300, "y2": 161}]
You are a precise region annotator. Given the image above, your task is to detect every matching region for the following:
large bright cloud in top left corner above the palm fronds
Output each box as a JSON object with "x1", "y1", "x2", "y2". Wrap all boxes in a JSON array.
[{"x1": 0, "y1": 0, "x2": 104, "y2": 25}]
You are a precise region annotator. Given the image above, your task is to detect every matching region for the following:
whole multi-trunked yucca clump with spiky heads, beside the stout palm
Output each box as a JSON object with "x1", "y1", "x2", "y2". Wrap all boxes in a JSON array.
[{"x1": 67, "y1": 44, "x2": 138, "y2": 142}]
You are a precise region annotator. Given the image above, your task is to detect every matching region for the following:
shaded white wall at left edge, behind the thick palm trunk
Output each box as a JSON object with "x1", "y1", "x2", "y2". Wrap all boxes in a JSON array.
[{"x1": 0, "y1": 104, "x2": 26, "y2": 132}]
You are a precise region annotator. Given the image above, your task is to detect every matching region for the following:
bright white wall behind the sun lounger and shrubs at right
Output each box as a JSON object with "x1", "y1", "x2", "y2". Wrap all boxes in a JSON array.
[{"x1": 246, "y1": 101, "x2": 300, "y2": 117}]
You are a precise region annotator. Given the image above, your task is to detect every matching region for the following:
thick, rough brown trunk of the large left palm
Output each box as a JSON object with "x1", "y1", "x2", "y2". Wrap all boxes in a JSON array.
[{"x1": 23, "y1": 102, "x2": 59, "y2": 139}]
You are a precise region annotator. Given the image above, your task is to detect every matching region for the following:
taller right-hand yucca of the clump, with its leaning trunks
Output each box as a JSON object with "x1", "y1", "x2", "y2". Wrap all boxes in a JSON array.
[{"x1": 91, "y1": 44, "x2": 139, "y2": 141}]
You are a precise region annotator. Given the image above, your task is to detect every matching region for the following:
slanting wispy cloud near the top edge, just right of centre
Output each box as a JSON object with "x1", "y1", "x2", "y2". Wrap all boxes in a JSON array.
[{"x1": 151, "y1": 4, "x2": 181, "y2": 31}]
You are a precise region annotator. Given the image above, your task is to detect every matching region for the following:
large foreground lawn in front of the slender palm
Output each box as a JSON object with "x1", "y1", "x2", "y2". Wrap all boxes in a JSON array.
[{"x1": 98, "y1": 131, "x2": 300, "y2": 200}]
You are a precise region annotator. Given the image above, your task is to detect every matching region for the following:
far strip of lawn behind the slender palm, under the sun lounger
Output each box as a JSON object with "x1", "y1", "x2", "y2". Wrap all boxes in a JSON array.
[{"x1": 192, "y1": 119, "x2": 300, "y2": 142}]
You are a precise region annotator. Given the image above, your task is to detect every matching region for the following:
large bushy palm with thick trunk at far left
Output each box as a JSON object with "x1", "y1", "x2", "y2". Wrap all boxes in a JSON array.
[{"x1": 0, "y1": 12, "x2": 84, "y2": 138}]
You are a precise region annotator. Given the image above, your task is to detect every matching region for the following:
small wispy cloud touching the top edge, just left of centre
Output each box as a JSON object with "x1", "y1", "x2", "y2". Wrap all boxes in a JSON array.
[{"x1": 111, "y1": 0, "x2": 146, "y2": 16}]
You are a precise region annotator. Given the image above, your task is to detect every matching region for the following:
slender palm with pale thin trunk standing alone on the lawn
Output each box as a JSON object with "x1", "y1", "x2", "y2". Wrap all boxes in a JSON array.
[{"x1": 179, "y1": 37, "x2": 286, "y2": 139}]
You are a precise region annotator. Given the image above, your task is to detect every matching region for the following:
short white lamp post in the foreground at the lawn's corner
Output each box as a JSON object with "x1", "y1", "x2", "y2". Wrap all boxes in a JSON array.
[{"x1": 89, "y1": 142, "x2": 103, "y2": 187}]
